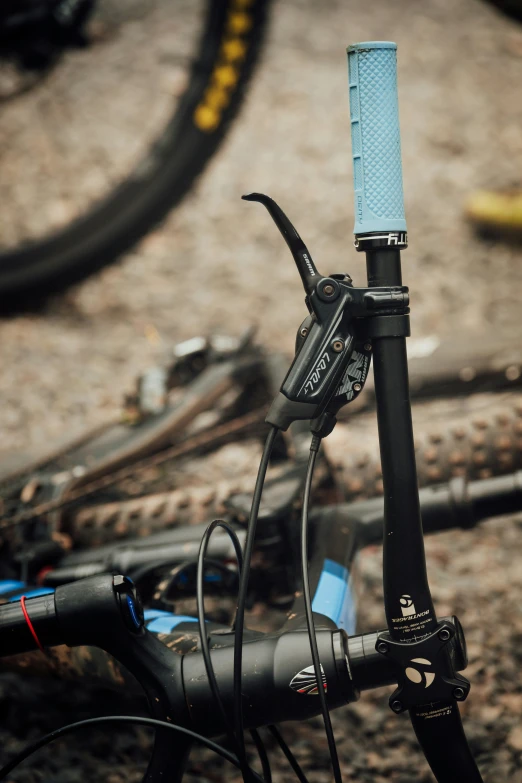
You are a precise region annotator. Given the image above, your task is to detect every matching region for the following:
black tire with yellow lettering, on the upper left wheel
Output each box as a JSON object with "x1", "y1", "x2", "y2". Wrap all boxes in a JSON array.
[{"x1": 0, "y1": 0, "x2": 270, "y2": 307}]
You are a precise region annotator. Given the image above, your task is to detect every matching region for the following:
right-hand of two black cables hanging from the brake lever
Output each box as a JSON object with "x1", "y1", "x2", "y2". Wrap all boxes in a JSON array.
[{"x1": 301, "y1": 435, "x2": 342, "y2": 783}]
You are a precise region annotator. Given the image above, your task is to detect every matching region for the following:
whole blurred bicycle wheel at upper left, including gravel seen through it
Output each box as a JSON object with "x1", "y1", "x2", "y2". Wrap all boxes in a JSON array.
[{"x1": 0, "y1": 0, "x2": 269, "y2": 304}]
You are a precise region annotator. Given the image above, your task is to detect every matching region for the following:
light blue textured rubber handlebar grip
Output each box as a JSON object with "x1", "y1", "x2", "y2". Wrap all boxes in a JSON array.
[{"x1": 347, "y1": 41, "x2": 406, "y2": 234}]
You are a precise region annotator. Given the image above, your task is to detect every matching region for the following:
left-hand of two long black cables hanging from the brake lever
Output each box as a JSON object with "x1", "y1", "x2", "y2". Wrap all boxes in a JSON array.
[{"x1": 234, "y1": 427, "x2": 279, "y2": 780}]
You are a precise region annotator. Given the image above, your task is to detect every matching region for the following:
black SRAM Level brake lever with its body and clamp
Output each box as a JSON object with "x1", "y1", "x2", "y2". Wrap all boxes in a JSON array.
[{"x1": 243, "y1": 193, "x2": 409, "y2": 438}]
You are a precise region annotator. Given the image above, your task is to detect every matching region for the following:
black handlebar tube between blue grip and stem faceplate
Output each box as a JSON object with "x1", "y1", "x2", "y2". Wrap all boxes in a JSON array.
[{"x1": 366, "y1": 250, "x2": 437, "y2": 641}]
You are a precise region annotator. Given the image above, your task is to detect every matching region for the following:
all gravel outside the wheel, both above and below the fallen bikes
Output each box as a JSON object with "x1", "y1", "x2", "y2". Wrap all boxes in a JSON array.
[{"x1": 0, "y1": 0, "x2": 522, "y2": 783}]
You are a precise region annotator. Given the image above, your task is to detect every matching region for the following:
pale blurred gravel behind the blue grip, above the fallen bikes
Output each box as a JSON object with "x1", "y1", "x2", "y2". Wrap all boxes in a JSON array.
[{"x1": 0, "y1": 0, "x2": 522, "y2": 460}]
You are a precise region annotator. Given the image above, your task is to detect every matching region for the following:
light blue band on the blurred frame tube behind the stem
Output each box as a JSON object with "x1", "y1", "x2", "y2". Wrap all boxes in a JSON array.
[{"x1": 312, "y1": 558, "x2": 356, "y2": 634}]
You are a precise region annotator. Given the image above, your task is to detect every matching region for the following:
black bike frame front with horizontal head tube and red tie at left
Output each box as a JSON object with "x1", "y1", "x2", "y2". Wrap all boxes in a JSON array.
[{"x1": 0, "y1": 574, "x2": 465, "y2": 783}]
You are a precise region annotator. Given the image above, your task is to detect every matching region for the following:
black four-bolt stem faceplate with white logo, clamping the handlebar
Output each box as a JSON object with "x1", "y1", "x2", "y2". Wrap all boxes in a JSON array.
[{"x1": 375, "y1": 617, "x2": 470, "y2": 713}]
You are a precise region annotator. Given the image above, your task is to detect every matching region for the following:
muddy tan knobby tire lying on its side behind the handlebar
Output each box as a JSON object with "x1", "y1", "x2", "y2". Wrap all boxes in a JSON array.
[{"x1": 51, "y1": 394, "x2": 522, "y2": 548}]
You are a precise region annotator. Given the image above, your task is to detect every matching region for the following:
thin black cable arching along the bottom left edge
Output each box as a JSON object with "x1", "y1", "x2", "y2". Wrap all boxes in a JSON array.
[{"x1": 0, "y1": 715, "x2": 264, "y2": 783}]
